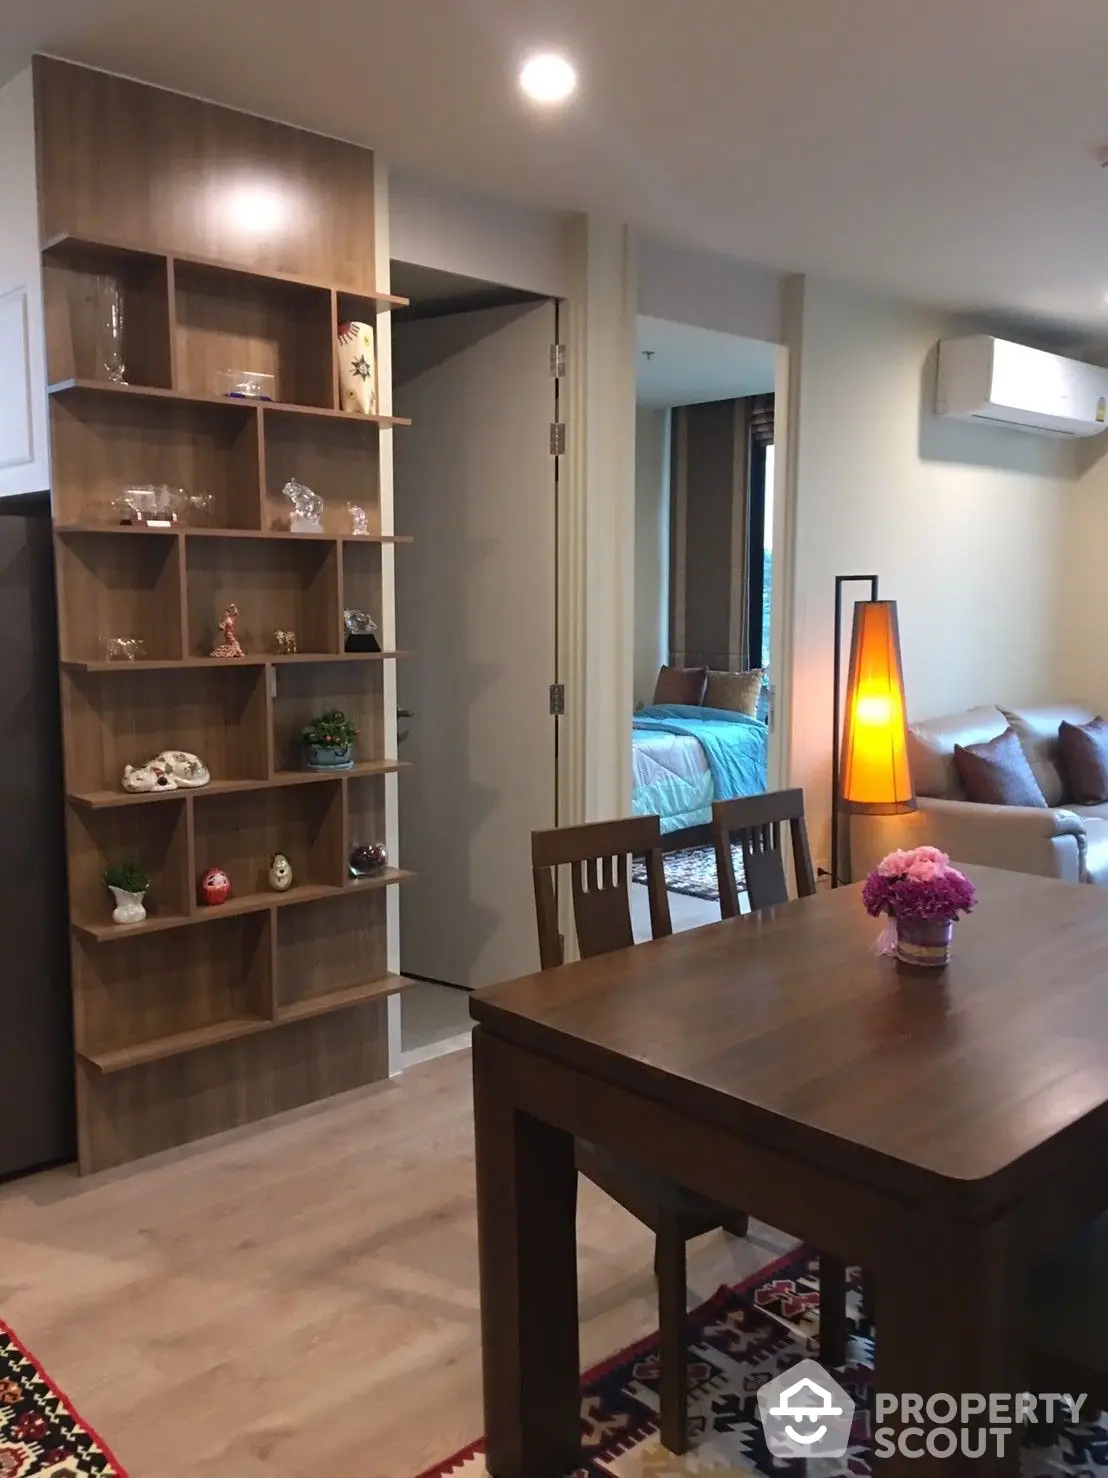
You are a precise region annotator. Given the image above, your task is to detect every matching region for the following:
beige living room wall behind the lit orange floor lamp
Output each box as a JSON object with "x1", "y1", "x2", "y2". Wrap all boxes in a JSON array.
[{"x1": 787, "y1": 279, "x2": 1081, "y2": 859}]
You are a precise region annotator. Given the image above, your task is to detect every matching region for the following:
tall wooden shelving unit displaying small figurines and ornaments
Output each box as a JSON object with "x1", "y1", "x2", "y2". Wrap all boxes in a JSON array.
[{"x1": 35, "y1": 61, "x2": 412, "y2": 1171}]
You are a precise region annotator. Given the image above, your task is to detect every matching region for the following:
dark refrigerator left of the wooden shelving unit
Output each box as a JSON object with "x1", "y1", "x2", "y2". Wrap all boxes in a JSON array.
[{"x1": 0, "y1": 495, "x2": 75, "y2": 1178}]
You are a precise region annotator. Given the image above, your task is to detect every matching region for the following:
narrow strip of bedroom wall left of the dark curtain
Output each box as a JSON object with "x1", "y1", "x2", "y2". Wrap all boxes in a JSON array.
[{"x1": 635, "y1": 406, "x2": 671, "y2": 704}]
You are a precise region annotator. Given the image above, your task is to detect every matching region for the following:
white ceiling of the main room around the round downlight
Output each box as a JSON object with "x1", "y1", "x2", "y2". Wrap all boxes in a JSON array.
[{"x1": 0, "y1": 0, "x2": 1108, "y2": 330}]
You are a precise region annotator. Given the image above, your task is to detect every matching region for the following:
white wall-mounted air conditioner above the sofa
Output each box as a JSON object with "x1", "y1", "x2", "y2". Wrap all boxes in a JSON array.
[{"x1": 935, "y1": 334, "x2": 1108, "y2": 436}]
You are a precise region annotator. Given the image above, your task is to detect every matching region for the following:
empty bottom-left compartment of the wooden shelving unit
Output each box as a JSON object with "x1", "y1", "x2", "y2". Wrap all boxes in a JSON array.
[{"x1": 74, "y1": 913, "x2": 273, "y2": 1073}]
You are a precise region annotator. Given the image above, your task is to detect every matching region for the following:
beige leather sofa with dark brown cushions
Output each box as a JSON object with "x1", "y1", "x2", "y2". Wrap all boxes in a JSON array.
[{"x1": 903, "y1": 704, "x2": 1108, "y2": 884}]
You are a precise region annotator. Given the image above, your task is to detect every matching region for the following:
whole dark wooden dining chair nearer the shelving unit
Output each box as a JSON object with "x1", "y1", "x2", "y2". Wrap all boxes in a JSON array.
[{"x1": 530, "y1": 816, "x2": 845, "y2": 1453}]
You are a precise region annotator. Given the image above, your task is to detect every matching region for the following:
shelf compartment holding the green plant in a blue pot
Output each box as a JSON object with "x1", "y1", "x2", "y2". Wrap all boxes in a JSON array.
[{"x1": 273, "y1": 658, "x2": 384, "y2": 776}]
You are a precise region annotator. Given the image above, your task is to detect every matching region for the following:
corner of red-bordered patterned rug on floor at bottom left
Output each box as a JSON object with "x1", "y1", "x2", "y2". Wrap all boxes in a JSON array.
[{"x1": 0, "y1": 1323, "x2": 127, "y2": 1478}]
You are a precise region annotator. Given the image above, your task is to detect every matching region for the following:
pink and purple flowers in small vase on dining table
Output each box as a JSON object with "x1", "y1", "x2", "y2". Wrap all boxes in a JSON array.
[{"x1": 861, "y1": 847, "x2": 975, "y2": 970}]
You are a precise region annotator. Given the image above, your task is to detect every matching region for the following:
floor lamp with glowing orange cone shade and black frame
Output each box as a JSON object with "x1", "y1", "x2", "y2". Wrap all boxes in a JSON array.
[{"x1": 830, "y1": 575, "x2": 917, "y2": 888}]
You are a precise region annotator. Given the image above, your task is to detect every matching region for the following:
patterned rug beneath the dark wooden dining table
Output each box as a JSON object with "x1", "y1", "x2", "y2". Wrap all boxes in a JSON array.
[{"x1": 421, "y1": 1250, "x2": 1108, "y2": 1478}]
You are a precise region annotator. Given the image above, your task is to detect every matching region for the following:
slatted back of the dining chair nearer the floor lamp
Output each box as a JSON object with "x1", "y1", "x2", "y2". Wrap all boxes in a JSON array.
[{"x1": 712, "y1": 791, "x2": 815, "y2": 919}]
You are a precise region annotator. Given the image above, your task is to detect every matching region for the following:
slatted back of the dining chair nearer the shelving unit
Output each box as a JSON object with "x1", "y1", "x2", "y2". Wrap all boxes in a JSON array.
[{"x1": 530, "y1": 816, "x2": 674, "y2": 970}]
